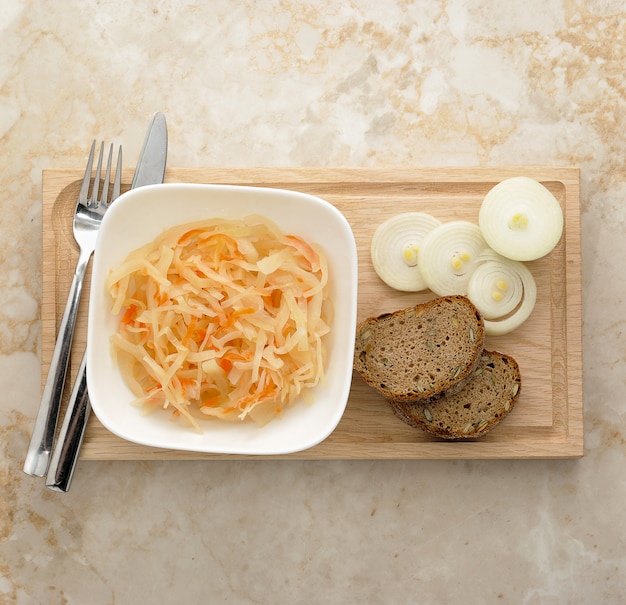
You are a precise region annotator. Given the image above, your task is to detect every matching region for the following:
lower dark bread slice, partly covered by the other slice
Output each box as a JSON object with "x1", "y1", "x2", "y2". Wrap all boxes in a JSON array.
[{"x1": 389, "y1": 351, "x2": 522, "y2": 439}]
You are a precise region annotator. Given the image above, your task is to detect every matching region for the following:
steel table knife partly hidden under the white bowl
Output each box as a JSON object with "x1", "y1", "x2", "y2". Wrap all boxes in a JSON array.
[{"x1": 46, "y1": 112, "x2": 167, "y2": 492}]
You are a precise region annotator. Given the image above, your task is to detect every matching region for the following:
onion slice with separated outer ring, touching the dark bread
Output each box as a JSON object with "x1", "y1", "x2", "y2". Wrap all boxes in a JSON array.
[{"x1": 467, "y1": 250, "x2": 537, "y2": 336}]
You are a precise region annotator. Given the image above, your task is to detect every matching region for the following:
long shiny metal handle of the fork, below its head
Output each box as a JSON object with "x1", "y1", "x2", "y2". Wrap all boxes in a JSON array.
[{"x1": 24, "y1": 250, "x2": 91, "y2": 477}]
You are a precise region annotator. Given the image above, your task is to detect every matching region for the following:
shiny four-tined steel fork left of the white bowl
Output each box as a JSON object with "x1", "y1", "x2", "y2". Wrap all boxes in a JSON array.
[{"x1": 24, "y1": 140, "x2": 122, "y2": 477}]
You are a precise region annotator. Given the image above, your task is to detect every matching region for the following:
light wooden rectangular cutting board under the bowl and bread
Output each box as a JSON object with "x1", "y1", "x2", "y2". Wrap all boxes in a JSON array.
[{"x1": 42, "y1": 167, "x2": 583, "y2": 460}]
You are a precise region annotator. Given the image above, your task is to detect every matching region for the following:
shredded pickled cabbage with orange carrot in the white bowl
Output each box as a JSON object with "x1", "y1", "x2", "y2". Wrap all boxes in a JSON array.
[{"x1": 107, "y1": 216, "x2": 331, "y2": 430}]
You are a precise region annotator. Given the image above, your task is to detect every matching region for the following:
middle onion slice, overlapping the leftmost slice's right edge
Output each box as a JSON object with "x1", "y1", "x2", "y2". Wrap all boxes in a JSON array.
[{"x1": 417, "y1": 221, "x2": 487, "y2": 296}]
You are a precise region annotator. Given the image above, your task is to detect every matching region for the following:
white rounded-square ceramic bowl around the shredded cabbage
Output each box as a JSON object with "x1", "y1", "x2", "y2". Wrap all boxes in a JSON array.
[{"x1": 87, "y1": 184, "x2": 357, "y2": 455}]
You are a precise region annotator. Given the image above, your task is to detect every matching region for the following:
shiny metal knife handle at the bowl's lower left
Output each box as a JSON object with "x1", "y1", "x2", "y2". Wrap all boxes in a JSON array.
[{"x1": 46, "y1": 355, "x2": 91, "y2": 492}]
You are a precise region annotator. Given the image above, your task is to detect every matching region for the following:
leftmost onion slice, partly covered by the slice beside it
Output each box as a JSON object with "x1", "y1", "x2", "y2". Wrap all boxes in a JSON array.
[{"x1": 371, "y1": 212, "x2": 441, "y2": 292}]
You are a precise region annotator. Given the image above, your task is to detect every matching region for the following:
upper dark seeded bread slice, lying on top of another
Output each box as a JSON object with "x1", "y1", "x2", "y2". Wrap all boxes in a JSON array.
[{"x1": 354, "y1": 295, "x2": 485, "y2": 402}]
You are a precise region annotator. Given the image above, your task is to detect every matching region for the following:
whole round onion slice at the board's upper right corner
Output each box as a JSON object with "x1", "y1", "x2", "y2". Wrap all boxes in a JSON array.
[{"x1": 478, "y1": 176, "x2": 563, "y2": 261}]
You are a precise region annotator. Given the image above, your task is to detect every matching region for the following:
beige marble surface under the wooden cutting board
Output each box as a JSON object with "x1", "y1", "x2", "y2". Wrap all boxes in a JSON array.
[{"x1": 0, "y1": 0, "x2": 626, "y2": 605}]
